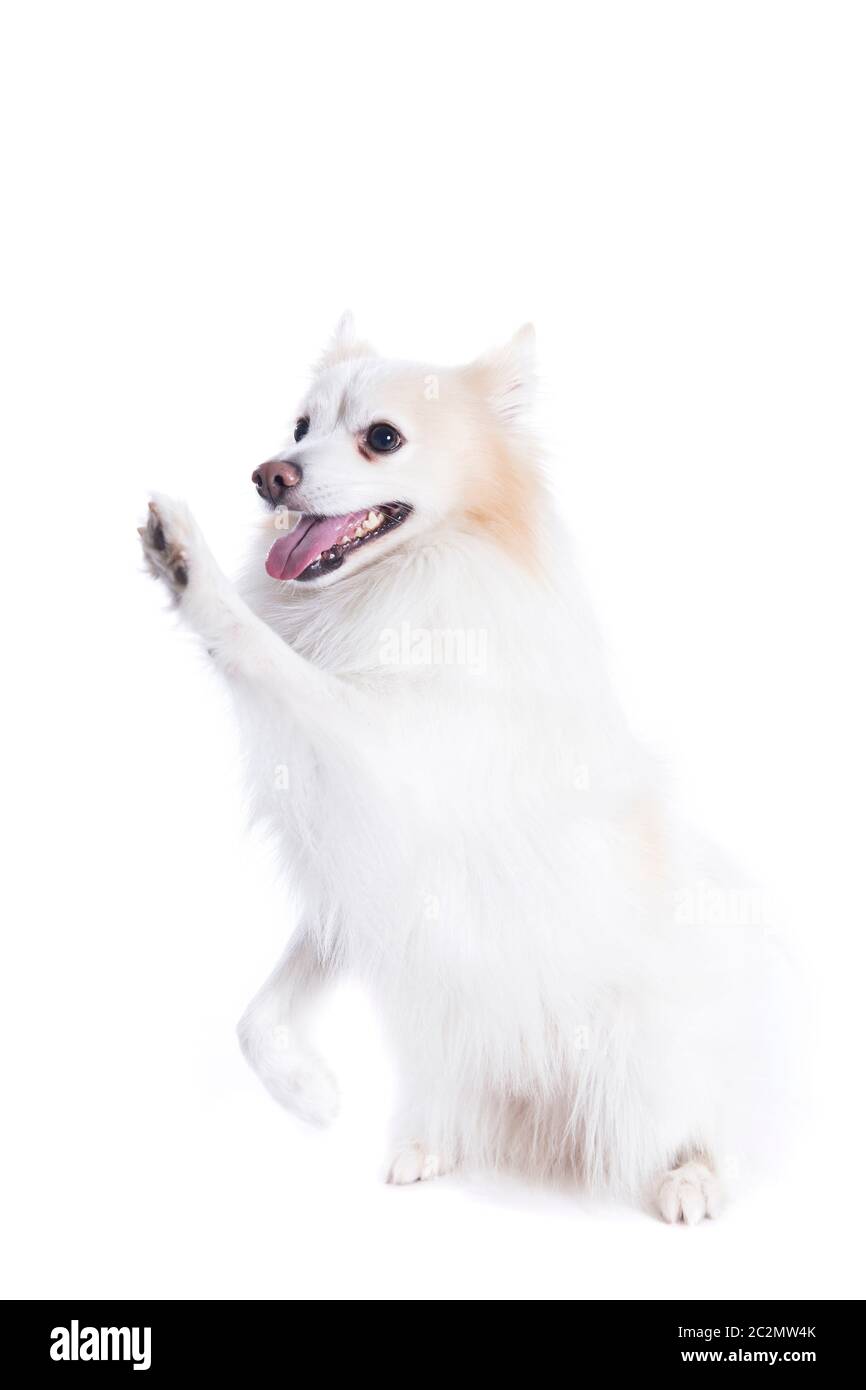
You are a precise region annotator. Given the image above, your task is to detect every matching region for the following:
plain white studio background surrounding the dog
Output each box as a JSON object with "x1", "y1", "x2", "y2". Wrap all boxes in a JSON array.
[{"x1": 0, "y1": 0, "x2": 866, "y2": 1300}]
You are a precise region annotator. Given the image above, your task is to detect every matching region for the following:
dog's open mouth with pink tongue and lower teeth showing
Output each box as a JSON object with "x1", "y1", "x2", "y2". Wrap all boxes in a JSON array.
[{"x1": 264, "y1": 502, "x2": 411, "y2": 580}]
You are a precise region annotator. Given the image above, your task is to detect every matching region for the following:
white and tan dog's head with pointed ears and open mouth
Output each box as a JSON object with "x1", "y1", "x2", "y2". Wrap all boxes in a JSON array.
[{"x1": 253, "y1": 316, "x2": 535, "y2": 584}]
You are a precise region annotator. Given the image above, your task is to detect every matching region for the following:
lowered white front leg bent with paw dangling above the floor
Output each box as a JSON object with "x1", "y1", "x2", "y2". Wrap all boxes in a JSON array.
[{"x1": 238, "y1": 926, "x2": 346, "y2": 1125}]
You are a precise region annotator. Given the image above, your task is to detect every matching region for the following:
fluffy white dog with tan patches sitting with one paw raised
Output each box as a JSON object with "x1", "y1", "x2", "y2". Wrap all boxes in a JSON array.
[{"x1": 140, "y1": 316, "x2": 783, "y2": 1225}]
